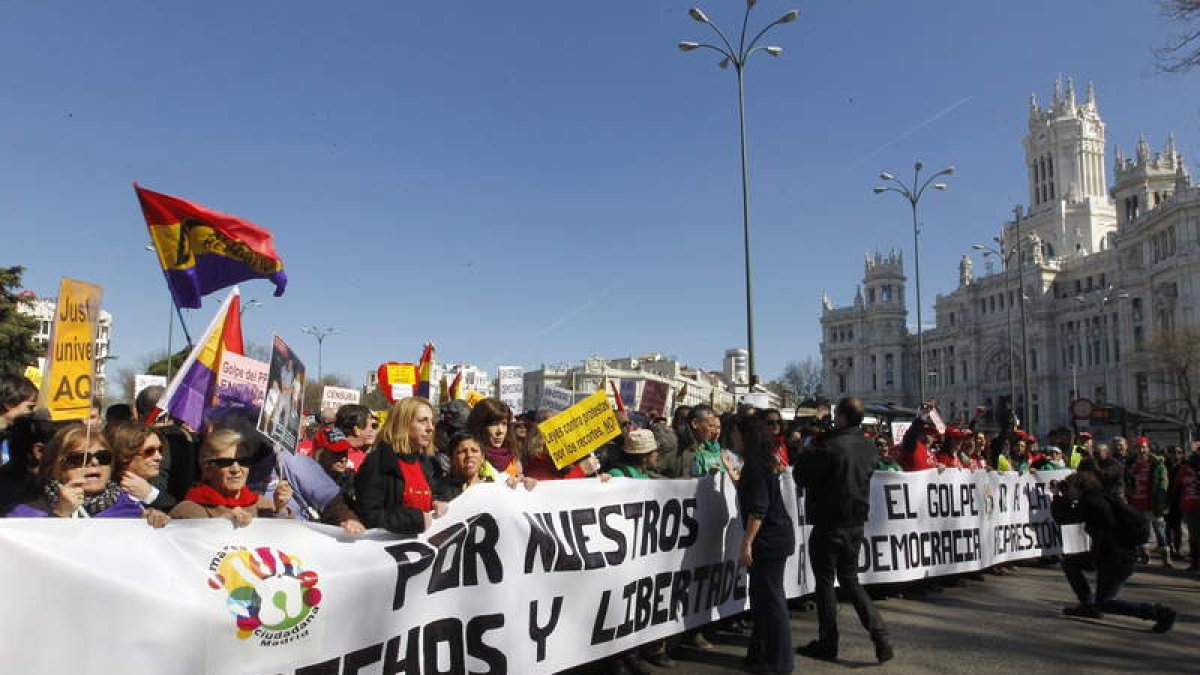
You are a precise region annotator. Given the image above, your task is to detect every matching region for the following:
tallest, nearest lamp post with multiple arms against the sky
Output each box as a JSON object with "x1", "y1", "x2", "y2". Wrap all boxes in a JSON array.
[{"x1": 679, "y1": 0, "x2": 800, "y2": 389}]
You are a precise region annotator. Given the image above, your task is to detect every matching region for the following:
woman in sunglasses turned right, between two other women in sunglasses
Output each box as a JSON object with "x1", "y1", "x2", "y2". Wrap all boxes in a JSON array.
[{"x1": 104, "y1": 422, "x2": 175, "y2": 518}]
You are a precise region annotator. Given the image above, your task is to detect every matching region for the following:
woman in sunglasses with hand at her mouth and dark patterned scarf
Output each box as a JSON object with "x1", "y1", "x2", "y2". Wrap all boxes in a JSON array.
[{"x1": 8, "y1": 423, "x2": 156, "y2": 527}]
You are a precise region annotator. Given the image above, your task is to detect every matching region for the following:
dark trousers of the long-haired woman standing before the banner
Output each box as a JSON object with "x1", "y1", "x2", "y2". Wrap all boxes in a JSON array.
[{"x1": 746, "y1": 557, "x2": 796, "y2": 673}]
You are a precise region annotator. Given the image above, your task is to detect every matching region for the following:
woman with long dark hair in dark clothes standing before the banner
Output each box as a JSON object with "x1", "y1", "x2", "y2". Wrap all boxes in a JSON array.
[{"x1": 738, "y1": 417, "x2": 796, "y2": 673}]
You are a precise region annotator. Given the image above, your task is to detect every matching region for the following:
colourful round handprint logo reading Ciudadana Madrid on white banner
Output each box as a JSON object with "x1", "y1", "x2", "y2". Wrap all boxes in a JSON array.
[{"x1": 209, "y1": 546, "x2": 322, "y2": 646}]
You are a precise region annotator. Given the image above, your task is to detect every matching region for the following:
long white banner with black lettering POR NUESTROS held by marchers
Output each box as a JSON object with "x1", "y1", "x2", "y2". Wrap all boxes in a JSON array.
[{"x1": 0, "y1": 471, "x2": 1078, "y2": 675}]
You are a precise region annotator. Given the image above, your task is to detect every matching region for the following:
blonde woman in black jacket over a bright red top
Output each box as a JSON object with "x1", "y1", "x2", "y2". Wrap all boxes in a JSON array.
[{"x1": 354, "y1": 396, "x2": 451, "y2": 534}]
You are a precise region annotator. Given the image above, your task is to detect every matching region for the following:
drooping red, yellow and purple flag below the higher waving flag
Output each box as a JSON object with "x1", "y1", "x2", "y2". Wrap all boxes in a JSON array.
[{"x1": 154, "y1": 286, "x2": 245, "y2": 429}]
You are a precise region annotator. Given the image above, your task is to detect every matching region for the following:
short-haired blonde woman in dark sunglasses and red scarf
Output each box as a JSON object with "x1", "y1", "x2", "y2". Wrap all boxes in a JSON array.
[{"x1": 170, "y1": 429, "x2": 292, "y2": 527}]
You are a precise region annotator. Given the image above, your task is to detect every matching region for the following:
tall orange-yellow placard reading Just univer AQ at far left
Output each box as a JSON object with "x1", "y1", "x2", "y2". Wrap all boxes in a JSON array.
[{"x1": 40, "y1": 277, "x2": 101, "y2": 422}]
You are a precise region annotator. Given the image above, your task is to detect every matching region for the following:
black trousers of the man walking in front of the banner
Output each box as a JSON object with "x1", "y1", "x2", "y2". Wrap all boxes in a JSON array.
[{"x1": 809, "y1": 525, "x2": 888, "y2": 652}]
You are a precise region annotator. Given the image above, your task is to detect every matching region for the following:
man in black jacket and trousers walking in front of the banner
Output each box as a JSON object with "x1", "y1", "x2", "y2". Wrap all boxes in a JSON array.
[{"x1": 796, "y1": 396, "x2": 894, "y2": 663}]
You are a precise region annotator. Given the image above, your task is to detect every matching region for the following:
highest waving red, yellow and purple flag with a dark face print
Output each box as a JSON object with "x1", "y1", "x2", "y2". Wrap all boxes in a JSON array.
[{"x1": 133, "y1": 183, "x2": 288, "y2": 309}]
